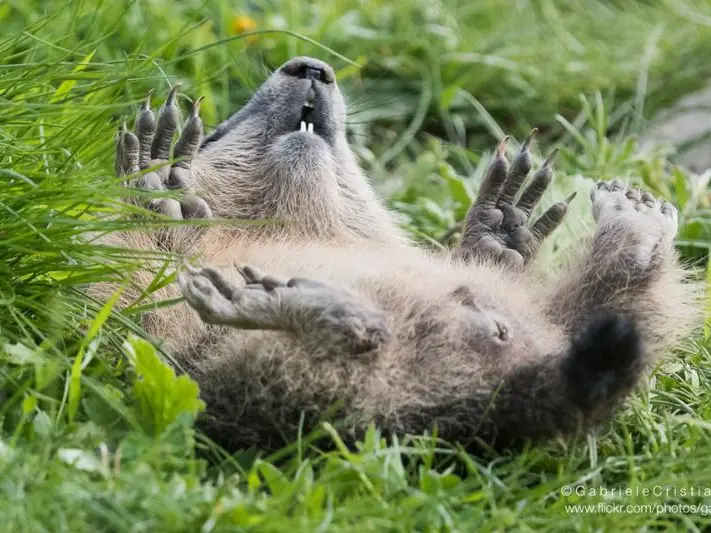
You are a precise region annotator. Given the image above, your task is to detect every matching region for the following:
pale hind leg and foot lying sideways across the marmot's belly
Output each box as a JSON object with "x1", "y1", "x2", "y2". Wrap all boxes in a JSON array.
[{"x1": 178, "y1": 267, "x2": 390, "y2": 357}]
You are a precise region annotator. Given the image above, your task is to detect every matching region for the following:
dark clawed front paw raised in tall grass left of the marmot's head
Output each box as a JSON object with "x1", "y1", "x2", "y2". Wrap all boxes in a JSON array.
[{"x1": 116, "y1": 85, "x2": 212, "y2": 219}]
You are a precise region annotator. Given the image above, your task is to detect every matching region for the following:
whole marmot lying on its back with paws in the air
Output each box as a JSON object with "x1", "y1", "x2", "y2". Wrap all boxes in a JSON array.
[{"x1": 110, "y1": 57, "x2": 698, "y2": 450}]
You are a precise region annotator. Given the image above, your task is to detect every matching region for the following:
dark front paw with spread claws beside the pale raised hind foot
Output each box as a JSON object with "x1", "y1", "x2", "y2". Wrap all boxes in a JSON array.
[{"x1": 456, "y1": 130, "x2": 575, "y2": 268}]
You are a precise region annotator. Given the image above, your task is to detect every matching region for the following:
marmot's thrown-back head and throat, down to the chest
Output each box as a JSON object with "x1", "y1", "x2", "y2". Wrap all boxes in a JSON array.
[{"x1": 193, "y1": 57, "x2": 400, "y2": 240}]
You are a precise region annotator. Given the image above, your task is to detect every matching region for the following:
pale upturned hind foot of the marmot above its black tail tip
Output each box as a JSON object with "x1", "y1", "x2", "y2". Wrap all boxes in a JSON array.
[{"x1": 591, "y1": 180, "x2": 679, "y2": 268}]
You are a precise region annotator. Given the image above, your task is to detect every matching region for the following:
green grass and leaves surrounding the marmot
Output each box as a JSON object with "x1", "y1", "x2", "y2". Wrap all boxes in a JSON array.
[{"x1": 0, "y1": 0, "x2": 711, "y2": 532}]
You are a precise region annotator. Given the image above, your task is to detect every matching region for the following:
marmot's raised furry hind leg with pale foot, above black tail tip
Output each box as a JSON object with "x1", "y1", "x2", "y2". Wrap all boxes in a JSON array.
[{"x1": 550, "y1": 181, "x2": 692, "y2": 332}]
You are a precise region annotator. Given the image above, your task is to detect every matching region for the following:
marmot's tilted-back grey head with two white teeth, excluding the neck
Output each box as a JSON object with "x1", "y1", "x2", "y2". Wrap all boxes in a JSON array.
[{"x1": 200, "y1": 57, "x2": 352, "y2": 210}]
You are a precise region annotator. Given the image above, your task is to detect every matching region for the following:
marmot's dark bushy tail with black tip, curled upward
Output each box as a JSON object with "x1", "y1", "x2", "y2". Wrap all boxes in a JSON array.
[{"x1": 484, "y1": 313, "x2": 647, "y2": 447}]
